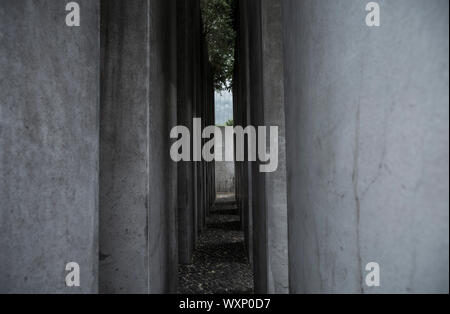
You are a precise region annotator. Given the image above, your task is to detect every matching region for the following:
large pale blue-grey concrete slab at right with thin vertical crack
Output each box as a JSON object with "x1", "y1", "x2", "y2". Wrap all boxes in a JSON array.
[{"x1": 284, "y1": 0, "x2": 449, "y2": 293}]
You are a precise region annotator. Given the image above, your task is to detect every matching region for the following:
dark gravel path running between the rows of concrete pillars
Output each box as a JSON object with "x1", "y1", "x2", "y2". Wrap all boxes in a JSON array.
[{"x1": 178, "y1": 197, "x2": 253, "y2": 294}]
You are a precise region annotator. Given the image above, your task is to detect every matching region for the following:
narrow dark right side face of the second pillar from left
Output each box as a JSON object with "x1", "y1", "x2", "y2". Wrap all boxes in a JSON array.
[{"x1": 148, "y1": 0, "x2": 178, "y2": 293}]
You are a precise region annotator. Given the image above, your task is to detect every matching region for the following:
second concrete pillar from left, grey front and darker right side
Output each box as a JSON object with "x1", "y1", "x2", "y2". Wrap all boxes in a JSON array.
[{"x1": 100, "y1": 0, "x2": 177, "y2": 293}]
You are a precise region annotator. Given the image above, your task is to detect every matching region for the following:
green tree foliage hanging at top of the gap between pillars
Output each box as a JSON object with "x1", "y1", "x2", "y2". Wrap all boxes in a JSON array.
[{"x1": 201, "y1": 0, "x2": 236, "y2": 91}]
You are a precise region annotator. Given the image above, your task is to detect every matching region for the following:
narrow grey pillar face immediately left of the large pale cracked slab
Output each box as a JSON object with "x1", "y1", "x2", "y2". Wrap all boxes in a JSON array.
[{"x1": 261, "y1": 0, "x2": 289, "y2": 293}]
